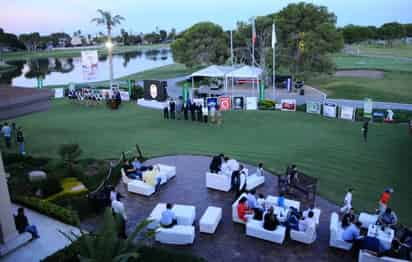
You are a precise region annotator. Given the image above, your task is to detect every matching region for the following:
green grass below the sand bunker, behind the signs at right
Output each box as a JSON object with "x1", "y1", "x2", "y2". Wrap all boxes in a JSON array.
[{"x1": 308, "y1": 72, "x2": 412, "y2": 104}]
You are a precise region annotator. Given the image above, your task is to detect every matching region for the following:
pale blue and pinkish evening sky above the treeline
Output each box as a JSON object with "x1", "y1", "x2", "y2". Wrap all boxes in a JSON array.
[{"x1": 0, "y1": 0, "x2": 412, "y2": 35}]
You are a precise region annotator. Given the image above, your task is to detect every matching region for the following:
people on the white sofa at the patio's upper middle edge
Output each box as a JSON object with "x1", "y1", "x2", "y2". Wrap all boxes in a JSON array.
[{"x1": 209, "y1": 154, "x2": 263, "y2": 196}]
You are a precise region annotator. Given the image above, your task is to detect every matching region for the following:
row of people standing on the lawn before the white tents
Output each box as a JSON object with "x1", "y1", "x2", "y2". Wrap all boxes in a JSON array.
[{"x1": 163, "y1": 97, "x2": 222, "y2": 125}]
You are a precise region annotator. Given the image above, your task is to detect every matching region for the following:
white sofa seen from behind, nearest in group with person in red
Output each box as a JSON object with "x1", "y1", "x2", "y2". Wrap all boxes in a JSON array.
[{"x1": 246, "y1": 219, "x2": 286, "y2": 244}]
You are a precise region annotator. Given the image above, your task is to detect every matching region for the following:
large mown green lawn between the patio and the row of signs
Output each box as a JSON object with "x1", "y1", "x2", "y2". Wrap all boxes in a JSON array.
[{"x1": 1, "y1": 100, "x2": 412, "y2": 226}]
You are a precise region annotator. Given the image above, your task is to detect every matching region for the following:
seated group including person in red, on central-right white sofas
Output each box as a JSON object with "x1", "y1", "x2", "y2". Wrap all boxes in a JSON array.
[{"x1": 237, "y1": 190, "x2": 316, "y2": 232}]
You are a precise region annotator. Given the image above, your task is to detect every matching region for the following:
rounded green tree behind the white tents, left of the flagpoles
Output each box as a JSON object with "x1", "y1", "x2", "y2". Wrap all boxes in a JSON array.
[{"x1": 172, "y1": 22, "x2": 229, "y2": 67}]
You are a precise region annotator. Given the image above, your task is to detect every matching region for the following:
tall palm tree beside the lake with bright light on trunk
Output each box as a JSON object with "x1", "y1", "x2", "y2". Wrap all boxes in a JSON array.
[{"x1": 92, "y1": 9, "x2": 124, "y2": 87}]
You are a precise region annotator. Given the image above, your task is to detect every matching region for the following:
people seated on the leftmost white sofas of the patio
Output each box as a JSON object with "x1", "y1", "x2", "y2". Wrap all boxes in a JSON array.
[{"x1": 123, "y1": 157, "x2": 162, "y2": 192}]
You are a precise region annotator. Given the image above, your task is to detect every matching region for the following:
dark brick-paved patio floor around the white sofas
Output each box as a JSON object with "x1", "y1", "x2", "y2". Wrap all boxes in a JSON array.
[{"x1": 83, "y1": 156, "x2": 353, "y2": 262}]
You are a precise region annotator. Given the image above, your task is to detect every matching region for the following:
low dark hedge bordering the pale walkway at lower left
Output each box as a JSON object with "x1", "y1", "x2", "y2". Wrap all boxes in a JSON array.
[{"x1": 12, "y1": 196, "x2": 80, "y2": 226}]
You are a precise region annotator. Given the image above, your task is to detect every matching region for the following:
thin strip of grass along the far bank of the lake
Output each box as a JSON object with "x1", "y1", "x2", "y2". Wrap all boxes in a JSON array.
[{"x1": 3, "y1": 44, "x2": 169, "y2": 61}]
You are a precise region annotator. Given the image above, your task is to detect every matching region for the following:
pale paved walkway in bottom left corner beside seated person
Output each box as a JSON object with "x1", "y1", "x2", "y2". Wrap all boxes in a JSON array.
[{"x1": 0, "y1": 205, "x2": 79, "y2": 262}]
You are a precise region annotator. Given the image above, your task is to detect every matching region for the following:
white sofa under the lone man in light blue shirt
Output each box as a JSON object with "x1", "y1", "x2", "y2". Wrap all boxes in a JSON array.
[{"x1": 155, "y1": 225, "x2": 195, "y2": 245}]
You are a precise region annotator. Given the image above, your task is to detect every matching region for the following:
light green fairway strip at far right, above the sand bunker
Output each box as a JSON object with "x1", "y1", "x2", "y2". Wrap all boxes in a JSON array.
[{"x1": 333, "y1": 54, "x2": 412, "y2": 72}]
